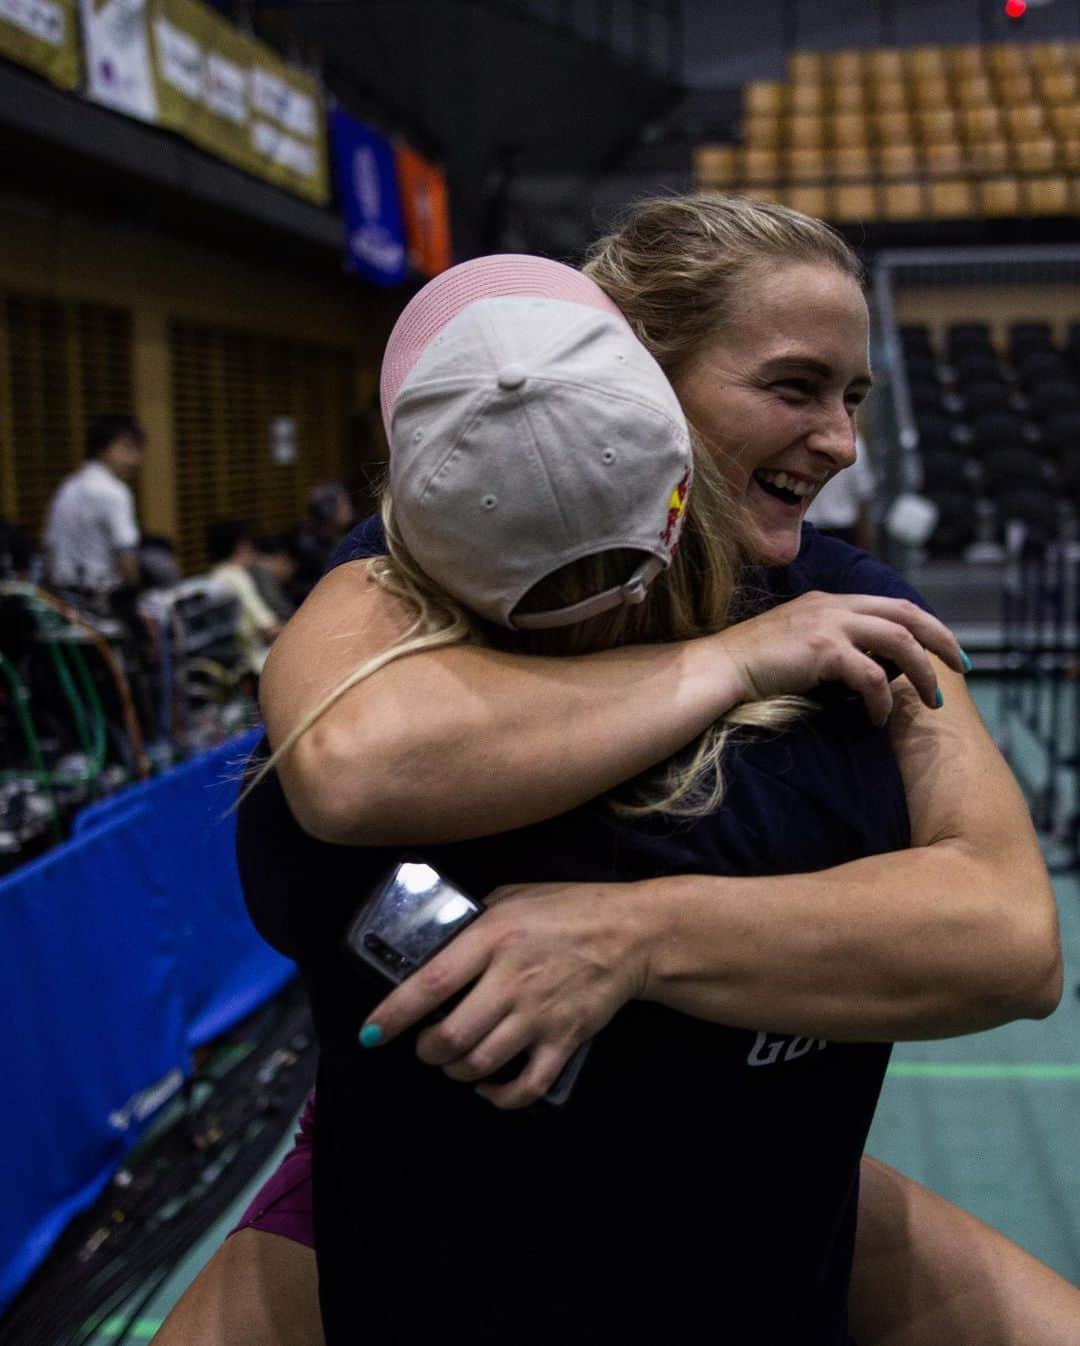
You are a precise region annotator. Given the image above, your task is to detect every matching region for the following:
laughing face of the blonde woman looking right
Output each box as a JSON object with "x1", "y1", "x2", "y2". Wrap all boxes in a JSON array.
[{"x1": 673, "y1": 262, "x2": 870, "y2": 565}]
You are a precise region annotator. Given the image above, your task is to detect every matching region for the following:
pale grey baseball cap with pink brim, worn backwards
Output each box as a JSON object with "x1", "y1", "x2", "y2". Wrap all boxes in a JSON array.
[{"x1": 381, "y1": 254, "x2": 692, "y2": 629}]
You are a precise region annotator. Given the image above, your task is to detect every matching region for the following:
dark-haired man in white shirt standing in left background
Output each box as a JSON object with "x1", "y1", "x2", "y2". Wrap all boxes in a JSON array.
[{"x1": 44, "y1": 416, "x2": 145, "y2": 594}]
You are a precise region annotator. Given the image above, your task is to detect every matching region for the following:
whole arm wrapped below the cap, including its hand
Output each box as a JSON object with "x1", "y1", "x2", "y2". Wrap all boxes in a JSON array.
[{"x1": 260, "y1": 561, "x2": 960, "y2": 845}]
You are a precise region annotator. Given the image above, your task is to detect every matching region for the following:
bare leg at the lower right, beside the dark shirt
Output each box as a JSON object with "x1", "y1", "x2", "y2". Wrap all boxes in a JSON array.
[{"x1": 851, "y1": 1156, "x2": 1080, "y2": 1346}]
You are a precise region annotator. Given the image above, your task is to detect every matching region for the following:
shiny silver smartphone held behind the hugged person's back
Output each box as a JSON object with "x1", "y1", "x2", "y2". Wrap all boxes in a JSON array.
[{"x1": 345, "y1": 860, "x2": 590, "y2": 1106}]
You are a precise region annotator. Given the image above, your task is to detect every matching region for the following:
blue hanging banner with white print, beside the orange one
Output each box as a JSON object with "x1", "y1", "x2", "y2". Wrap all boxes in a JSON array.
[{"x1": 330, "y1": 108, "x2": 408, "y2": 285}]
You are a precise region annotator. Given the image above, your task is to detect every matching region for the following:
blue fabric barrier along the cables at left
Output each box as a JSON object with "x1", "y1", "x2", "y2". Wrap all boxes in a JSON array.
[{"x1": 0, "y1": 730, "x2": 295, "y2": 1311}]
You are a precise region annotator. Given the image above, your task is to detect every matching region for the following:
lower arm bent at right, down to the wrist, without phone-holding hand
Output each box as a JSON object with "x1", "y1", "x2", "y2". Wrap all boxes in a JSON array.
[{"x1": 637, "y1": 665, "x2": 1061, "y2": 1040}]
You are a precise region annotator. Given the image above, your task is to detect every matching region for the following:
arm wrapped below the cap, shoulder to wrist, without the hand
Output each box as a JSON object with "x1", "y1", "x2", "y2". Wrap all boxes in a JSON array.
[{"x1": 260, "y1": 561, "x2": 742, "y2": 844}]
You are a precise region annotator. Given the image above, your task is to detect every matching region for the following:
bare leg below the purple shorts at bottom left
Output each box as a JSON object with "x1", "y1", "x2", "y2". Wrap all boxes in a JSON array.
[{"x1": 154, "y1": 1229, "x2": 323, "y2": 1346}]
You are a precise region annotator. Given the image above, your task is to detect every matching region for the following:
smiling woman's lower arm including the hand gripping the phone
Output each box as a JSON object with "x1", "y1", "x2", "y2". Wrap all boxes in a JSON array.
[{"x1": 372, "y1": 665, "x2": 1061, "y2": 1108}]
